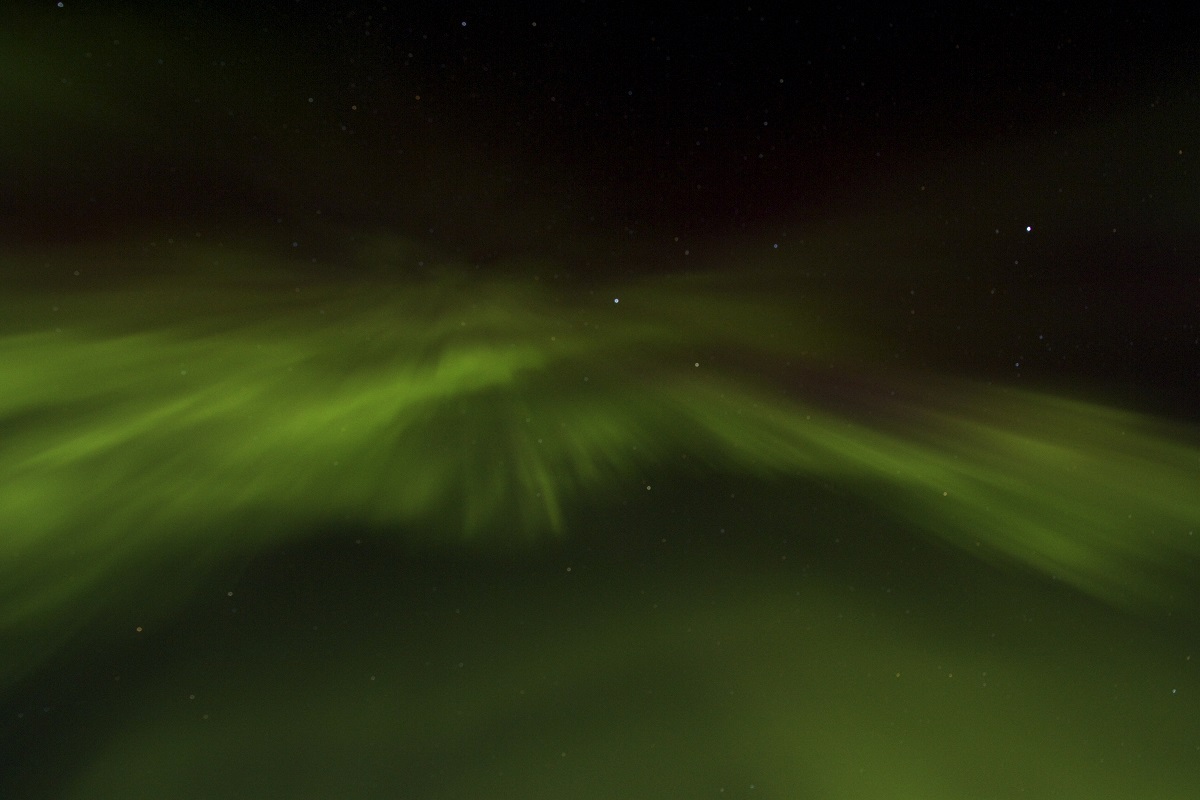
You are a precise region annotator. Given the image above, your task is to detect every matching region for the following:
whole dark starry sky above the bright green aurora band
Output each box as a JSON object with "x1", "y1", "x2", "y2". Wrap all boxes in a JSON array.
[{"x1": 7, "y1": 0, "x2": 1200, "y2": 407}]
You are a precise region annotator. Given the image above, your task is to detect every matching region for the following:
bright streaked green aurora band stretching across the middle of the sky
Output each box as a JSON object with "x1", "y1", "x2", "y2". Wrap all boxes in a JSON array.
[{"x1": 0, "y1": 239, "x2": 1200, "y2": 671}]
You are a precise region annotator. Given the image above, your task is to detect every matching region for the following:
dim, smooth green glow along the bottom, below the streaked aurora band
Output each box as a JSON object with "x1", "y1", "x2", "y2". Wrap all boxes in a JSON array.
[{"x1": 44, "y1": 558, "x2": 1196, "y2": 800}]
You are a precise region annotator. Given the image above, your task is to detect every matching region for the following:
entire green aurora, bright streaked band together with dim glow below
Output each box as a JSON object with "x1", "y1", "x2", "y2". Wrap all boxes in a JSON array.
[{"x1": 0, "y1": 236, "x2": 1200, "y2": 800}]
